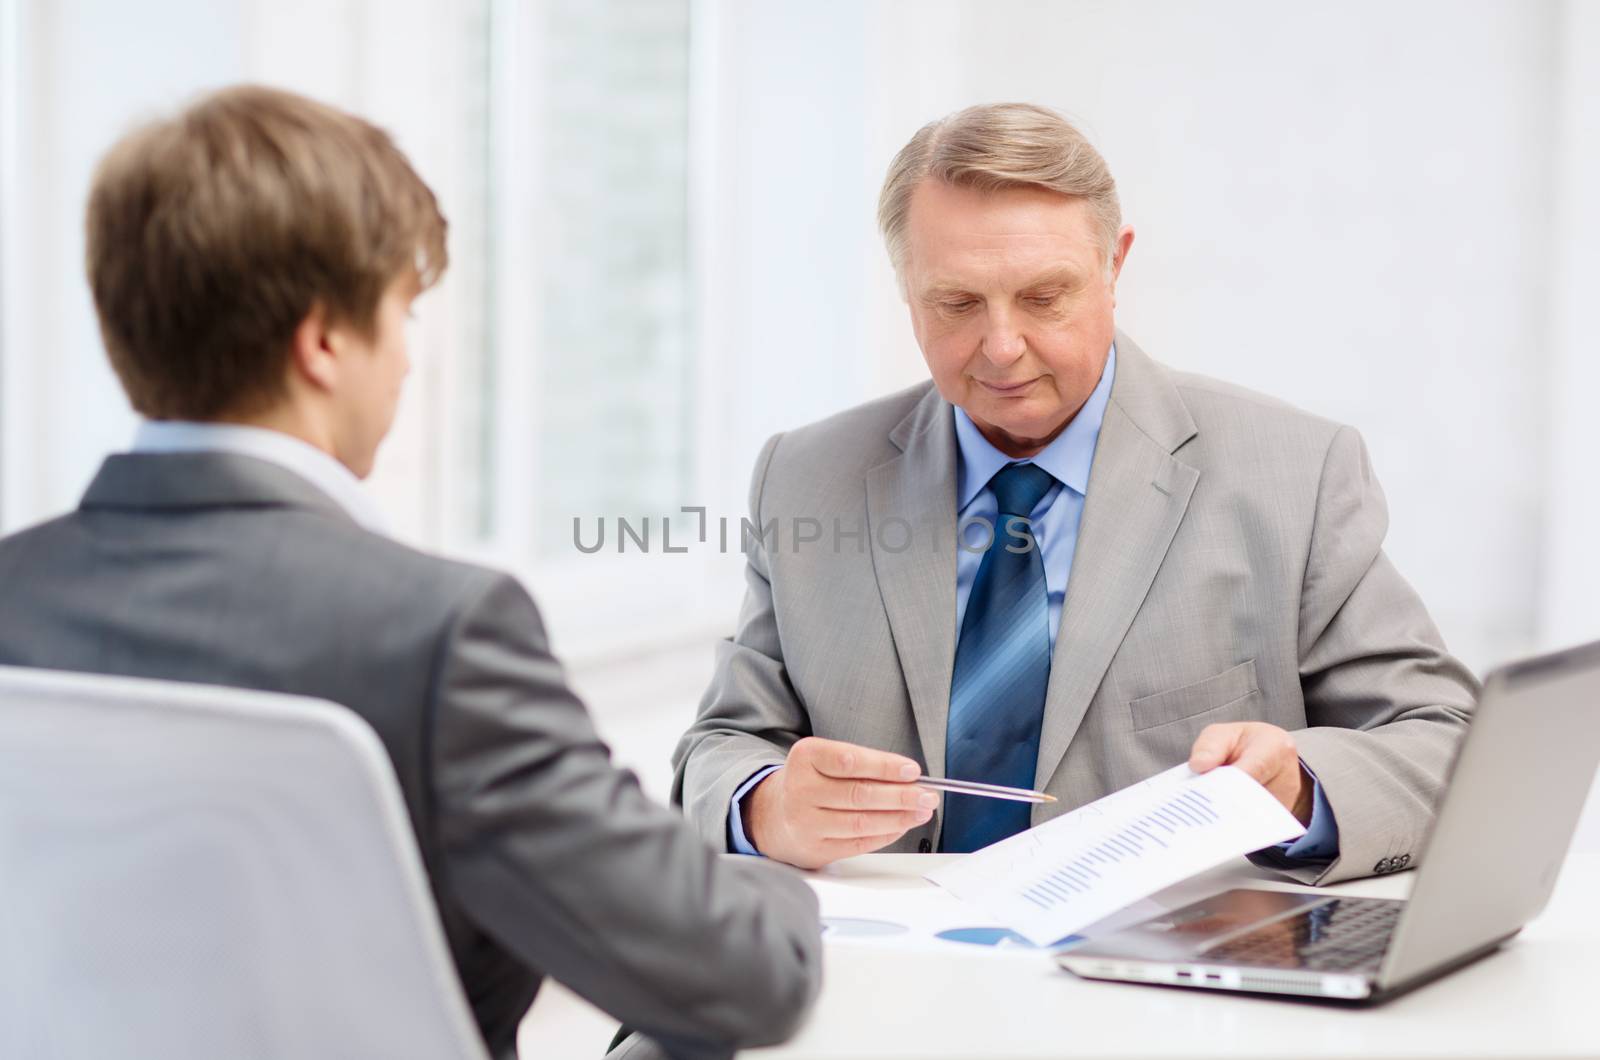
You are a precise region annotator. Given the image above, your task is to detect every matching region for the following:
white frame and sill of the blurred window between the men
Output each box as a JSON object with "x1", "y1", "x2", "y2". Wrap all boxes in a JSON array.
[{"x1": 446, "y1": 0, "x2": 744, "y2": 666}]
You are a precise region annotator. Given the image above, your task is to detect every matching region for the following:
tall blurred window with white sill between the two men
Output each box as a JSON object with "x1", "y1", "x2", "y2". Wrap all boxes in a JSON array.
[{"x1": 457, "y1": 0, "x2": 738, "y2": 656}]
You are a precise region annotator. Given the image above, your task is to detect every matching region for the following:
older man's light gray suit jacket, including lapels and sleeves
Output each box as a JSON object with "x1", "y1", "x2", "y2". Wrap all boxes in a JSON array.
[{"x1": 674, "y1": 333, "x2": 1477, "y2": 882}]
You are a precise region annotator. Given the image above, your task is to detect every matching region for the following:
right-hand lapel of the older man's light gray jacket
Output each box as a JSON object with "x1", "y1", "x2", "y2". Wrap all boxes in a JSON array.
[{"x1": 1035, "y1": 333, "x2": 1200, "y2": 788}]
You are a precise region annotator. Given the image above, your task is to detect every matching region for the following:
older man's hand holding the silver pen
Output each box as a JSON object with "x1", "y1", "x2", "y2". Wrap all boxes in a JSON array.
[{"x1": 742, "y1": 737, "x2": 939, "y2": 868}]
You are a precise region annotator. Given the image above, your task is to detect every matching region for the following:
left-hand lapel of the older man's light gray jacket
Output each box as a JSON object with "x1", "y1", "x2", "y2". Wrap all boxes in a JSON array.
[{"x1": 867, "y1": 386, "x2": 957, "y2": 777}]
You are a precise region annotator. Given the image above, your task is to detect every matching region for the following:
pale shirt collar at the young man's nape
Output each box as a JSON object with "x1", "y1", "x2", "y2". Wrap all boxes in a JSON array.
[{"x1": 133, "y1": 420, "x2": 389, "y2": 533}]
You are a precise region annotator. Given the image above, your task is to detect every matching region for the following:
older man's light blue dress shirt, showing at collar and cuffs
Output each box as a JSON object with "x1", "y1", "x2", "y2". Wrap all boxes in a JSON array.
[{"x1": 728, "y1": 346, "x2": 1339, "y2": 860}]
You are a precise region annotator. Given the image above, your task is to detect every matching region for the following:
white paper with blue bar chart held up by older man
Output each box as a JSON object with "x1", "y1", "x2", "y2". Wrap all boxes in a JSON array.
[{"x1": 926, "y1": 765, "x2": 1306, "y2": 946}]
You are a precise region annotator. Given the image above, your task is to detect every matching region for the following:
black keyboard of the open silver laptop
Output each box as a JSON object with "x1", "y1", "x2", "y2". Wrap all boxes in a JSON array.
[{"x1": 1203, "y1": 898, "x2": 1405, "y2": 972}]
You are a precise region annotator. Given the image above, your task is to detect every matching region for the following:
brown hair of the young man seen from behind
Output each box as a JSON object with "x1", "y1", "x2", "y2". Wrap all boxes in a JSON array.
[{"x1": 86, "y1": 85, "x2": 446, "y2": 420}]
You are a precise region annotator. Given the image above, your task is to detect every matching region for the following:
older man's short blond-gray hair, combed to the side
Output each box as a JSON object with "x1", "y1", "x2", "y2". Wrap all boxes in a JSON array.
[{"x1": 878, "y1": 102, "x2": 1122, "y2": 275}]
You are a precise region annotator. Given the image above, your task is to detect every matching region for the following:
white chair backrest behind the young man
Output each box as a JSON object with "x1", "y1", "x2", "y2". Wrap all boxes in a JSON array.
[{"x1": 0, "y1": 666, "x2": 486, "y2": 1060}]
